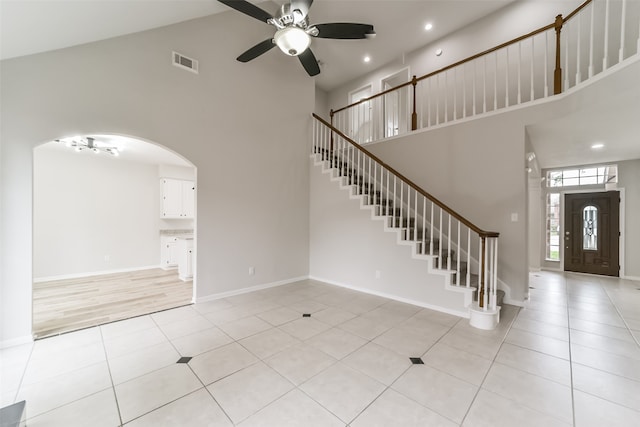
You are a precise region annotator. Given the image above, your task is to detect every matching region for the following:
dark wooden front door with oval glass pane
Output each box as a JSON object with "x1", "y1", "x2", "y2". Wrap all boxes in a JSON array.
[{"x1": 564, "y1": 191, "x2": 620, "y2": 276}]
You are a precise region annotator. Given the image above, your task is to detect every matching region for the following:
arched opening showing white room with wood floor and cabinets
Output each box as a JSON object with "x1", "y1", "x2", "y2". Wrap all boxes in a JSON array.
[{"x1": 32, "y1": 133, "x2": 197, "y2": 338}]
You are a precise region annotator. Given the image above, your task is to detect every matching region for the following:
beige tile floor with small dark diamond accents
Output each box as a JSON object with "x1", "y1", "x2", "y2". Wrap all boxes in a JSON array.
[{"x1": 0, "y1": 272, "x2": 640, "y2": 427}]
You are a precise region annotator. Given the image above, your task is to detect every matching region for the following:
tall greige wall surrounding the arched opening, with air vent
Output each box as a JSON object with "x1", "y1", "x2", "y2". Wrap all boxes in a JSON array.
[{"x1": 0, "y1": 11, "x2": 314, "y2": 346}]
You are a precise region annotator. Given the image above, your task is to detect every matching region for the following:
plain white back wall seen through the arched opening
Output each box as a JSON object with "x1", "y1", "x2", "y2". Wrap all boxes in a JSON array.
[{"x1": 33, "y1": 148, "x2": 160, "y2": 280}]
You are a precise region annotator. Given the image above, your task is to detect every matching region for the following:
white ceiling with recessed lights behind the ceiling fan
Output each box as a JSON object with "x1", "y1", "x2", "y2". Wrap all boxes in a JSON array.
[{"x1": 0, "y1": 0, "x2": 514, "y2": 90}]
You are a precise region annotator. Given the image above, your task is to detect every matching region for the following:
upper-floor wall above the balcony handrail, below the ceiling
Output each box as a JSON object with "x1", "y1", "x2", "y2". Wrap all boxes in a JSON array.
[{"x1": 329, "y1": 0, "x2": 583, "y2": 110}]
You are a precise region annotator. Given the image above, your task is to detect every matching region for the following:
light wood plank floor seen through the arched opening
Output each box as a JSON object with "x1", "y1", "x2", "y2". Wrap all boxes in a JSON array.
[{"x1": 33, "y1": 268, "x2": 193, "y2": 338}]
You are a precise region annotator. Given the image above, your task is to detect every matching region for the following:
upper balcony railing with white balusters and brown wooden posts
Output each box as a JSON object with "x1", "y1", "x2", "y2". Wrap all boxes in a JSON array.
[{"x1": 331, "y1": 0, "x2": 640, "y2": 144}]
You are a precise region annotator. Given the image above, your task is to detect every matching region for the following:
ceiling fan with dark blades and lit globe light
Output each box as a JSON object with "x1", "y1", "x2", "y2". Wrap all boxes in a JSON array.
[{"x1": 218, "y1": 0, "x2": 376, "y2": 76}]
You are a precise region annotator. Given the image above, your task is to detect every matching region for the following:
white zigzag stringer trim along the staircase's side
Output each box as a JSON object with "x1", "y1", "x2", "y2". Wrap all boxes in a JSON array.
[{"x1": 311, "y1": 154, "x2": 476, "y2": 317}]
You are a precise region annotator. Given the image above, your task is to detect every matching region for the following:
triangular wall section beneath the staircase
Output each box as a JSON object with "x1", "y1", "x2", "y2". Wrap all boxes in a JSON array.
[{"x1": 309, "y1": 160, "x2": 467, "y2": 316}]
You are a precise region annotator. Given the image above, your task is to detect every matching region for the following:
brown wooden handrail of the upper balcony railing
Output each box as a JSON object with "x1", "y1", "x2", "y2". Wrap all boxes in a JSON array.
[{"x1": 330, "y1": 0, "x2": 593, "y2": 115}]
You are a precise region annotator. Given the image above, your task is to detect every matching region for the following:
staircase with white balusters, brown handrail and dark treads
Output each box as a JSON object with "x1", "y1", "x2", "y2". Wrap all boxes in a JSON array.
[{"x1": 311, "y1": 116, "x2": 501, "y2": 329}]
